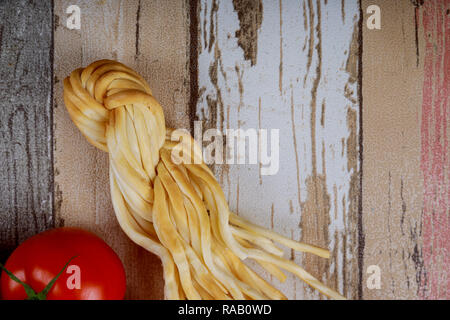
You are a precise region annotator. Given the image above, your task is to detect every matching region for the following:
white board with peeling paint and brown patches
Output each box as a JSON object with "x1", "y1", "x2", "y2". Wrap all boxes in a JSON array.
[{"x1": 196, "y1": 0, "x2": 360, "y2": 299}]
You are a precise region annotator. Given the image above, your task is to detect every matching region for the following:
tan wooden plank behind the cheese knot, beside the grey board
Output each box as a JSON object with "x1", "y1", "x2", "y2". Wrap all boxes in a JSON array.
[{"x1": 54, "y1": 0, "x2": 189, "y2": 299}]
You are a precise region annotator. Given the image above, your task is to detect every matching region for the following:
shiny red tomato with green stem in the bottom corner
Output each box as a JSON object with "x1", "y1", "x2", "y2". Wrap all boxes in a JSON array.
[{"x1": 0, "y1": 228, "x2": 126, "y2": 300}]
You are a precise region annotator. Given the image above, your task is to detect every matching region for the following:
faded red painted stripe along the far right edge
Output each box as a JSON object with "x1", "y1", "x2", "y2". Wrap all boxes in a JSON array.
[{"x1": 420, "y1": 0, "x2": 450, "y2": 299}]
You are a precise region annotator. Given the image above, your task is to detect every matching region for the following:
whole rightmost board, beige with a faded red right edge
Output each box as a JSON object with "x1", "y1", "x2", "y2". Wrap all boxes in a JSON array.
[{"x1": 362, "y1": 0, "x2": 450, "y2": 299}]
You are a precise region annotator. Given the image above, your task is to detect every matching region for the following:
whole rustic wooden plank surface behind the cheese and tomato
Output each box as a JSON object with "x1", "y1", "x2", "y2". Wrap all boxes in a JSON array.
[{"x1": 0, "y1": 0, "x2": 450, "y2": 299}]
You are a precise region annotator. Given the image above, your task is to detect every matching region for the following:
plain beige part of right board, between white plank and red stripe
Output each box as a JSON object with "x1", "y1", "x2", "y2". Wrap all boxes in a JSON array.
[{"x1": 362, "y1": 0, "x2": 424, "y2": 299}]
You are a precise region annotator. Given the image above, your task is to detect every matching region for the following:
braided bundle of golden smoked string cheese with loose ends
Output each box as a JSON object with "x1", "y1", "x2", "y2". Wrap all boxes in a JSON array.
[{"x1": 64, "y1": 60, "x2": 344, "y2": 299}]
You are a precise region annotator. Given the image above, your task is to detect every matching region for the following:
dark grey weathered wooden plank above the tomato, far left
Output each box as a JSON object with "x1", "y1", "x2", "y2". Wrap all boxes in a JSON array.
[{"x1": 0, "y1": 0, "x2": 54, "y2": 260}]
